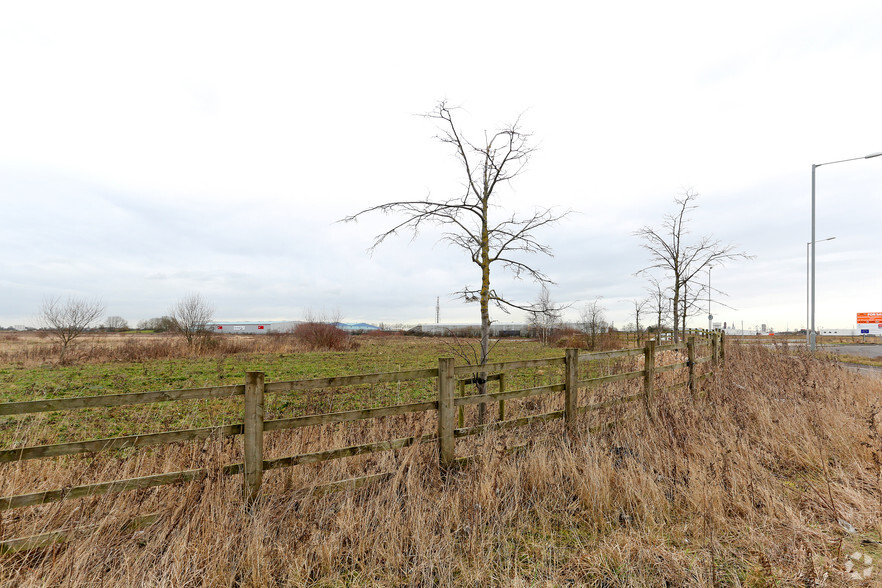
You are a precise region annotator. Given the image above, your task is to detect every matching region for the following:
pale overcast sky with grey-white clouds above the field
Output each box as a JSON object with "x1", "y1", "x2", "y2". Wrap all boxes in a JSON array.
[{"x1": 0, "y1": 0, "x2": 882, "y2": 330}]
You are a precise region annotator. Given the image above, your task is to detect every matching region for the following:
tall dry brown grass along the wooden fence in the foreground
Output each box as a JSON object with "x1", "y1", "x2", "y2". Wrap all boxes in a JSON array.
[{"x1": 0, "y1": 345, "x2": 882, "y2": 587}]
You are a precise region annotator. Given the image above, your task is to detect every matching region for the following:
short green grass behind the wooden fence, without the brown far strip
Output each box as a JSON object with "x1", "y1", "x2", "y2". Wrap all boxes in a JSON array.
[{"x1": 0, "y1": 338, "x2": 563, "y2": 448}]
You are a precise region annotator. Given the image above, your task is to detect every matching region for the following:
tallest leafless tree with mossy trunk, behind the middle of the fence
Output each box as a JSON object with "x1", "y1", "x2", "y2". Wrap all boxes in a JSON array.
[{"x1": 343, "y1": 102, "x2": 569, "y2": 400}]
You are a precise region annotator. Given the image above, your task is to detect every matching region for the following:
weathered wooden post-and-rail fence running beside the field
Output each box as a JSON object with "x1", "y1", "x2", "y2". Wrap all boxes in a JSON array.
[{"x1": 0, "y1": 333, "x2": 724, "y2": 553}]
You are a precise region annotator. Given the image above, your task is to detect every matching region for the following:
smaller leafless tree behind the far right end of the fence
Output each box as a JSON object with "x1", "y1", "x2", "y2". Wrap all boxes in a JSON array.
[{"x1": 634, "y1": 190, "x2": 750, "y2": 342}]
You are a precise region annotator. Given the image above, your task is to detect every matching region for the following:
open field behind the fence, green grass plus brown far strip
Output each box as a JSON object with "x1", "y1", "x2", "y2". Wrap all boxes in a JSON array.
[{"x1": 0, "y1": 336, "x2": 564, "y2": 446}]
